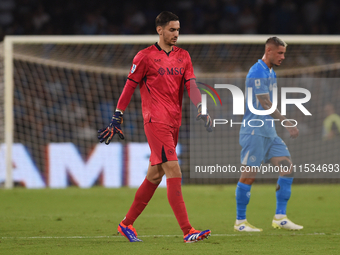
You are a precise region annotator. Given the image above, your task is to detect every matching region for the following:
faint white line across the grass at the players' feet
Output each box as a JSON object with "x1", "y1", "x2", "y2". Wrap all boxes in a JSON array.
[{"x1": 0, "y1": 232, "x2": 340, "y2": 240}]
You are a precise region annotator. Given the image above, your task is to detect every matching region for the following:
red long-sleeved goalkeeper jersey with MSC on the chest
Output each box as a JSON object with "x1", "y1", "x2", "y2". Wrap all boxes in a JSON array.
[{"x1": 117, "y1": 43, "x2": 201, "y2": 127}]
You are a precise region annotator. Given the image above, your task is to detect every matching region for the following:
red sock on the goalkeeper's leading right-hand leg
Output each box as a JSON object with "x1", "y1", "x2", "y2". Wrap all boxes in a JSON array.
[{"x1": 166, "y1": 178, "x2": 191, "y2": 235}]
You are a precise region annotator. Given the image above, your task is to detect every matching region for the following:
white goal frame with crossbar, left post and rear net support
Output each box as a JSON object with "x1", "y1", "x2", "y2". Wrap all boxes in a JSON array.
[{"x1": 0, "y1": 35, "x2": 340, "y2": 188}]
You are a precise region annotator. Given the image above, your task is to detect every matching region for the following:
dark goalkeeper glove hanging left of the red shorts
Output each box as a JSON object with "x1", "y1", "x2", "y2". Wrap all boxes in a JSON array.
[{"x1": 98, "y1": 111, "x2": 124, "y2": 144}]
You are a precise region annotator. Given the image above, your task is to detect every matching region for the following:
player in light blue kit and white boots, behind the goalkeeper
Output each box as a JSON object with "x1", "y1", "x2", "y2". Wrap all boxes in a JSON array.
[{"x1": 234, "y1": 37, "x2": 303, "y2": 232}]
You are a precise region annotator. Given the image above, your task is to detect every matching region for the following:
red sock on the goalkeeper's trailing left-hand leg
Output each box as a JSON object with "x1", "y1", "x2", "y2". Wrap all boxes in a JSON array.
[{"x1": 123, "y1": 178, "x2": 158, "y2": 226}]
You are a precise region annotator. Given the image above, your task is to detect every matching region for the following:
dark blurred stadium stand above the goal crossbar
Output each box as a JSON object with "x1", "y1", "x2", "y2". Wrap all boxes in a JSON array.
[{"x1": 0, "y1": 0, "x2": 340, "y2": 38}]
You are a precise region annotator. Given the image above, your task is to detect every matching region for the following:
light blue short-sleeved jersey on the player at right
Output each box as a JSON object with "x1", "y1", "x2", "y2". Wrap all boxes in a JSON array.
[{"x1": 240, "y1": 59, "x2": 277, "y2": 137}]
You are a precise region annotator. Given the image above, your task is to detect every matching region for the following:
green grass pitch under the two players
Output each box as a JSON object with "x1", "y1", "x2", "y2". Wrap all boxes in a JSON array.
[{"x1": 0, "y1": 184, "x2": 340, "y2": 255}]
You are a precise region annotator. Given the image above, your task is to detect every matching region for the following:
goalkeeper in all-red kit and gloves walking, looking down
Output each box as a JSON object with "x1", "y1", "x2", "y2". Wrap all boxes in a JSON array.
[{"x1": 98, "y1": 11, "x2": 212, "y2": 243}]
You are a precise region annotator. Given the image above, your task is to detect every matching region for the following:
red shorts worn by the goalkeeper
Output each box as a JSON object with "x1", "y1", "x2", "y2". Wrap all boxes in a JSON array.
[{"x1": 144, "y1": 122, "x2": 179, "y2": 166}]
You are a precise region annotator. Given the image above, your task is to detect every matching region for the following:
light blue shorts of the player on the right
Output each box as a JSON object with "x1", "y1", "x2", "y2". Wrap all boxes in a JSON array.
[{"x1": 240, "y1": 135, "x2": 290, "y2": 166}]
